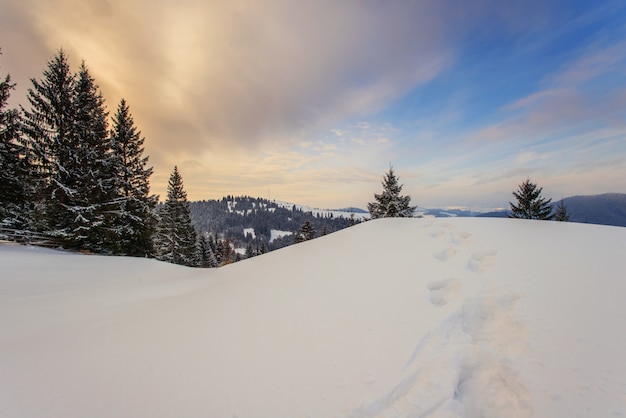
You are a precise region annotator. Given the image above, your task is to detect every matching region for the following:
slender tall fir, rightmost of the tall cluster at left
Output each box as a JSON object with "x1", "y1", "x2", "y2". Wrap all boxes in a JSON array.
[{"x1": 110, "y1": 99, "x2": 158, "y2": 257}]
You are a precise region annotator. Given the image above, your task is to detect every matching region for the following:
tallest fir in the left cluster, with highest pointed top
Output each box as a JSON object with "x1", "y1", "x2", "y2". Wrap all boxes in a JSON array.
[{"x1": 23, "y1": 50, "x2": 76, "y2": 243}]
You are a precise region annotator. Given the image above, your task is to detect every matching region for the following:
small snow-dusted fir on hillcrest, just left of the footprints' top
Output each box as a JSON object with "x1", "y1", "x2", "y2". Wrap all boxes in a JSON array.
[{"x1": 367, "y1": 166, "x2": 416, "y2": 219}]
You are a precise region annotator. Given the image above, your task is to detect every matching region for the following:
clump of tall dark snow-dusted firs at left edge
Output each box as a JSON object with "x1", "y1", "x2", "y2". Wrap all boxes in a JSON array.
[{"x1": 0, "y1": 50, "x2": 156, "y2": 256}]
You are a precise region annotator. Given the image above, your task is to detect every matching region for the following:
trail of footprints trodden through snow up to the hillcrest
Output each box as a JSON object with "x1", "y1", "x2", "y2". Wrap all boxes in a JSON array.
[{"x1": 352, "y1": 222, "x2": 533, "y2": 418}]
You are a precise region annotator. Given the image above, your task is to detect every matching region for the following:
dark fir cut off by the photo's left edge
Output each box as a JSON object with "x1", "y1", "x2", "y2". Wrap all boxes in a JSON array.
[{"x1": 0, "y1": 51, "x2": 28, "y2": 229}]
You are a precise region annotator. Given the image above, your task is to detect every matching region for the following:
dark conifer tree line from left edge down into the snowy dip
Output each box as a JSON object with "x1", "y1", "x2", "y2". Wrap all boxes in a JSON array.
[{"x1": 0, "y1": 49, "x2": 358, "y2": 267}]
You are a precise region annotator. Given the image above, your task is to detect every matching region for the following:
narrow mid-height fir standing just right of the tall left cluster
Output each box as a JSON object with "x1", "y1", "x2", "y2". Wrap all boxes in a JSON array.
[{"x1": 156, "y1": 167, "x2": 198, "y2": 266}]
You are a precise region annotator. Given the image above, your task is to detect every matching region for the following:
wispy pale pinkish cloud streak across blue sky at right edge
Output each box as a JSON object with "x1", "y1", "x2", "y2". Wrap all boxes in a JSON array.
[{"x1": 468, "y1": 34, "x2": 626, "y2": 144}]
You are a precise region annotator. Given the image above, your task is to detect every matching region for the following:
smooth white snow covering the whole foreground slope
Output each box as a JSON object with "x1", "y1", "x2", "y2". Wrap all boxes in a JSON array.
[{"x1": 0, "y1": 218, "x2": 626, "y2": 418}]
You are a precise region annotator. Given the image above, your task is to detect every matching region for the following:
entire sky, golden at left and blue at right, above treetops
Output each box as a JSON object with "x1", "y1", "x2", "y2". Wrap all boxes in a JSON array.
[{"x1": 0, "y1": 0, "x2": 626, "y2": 210}]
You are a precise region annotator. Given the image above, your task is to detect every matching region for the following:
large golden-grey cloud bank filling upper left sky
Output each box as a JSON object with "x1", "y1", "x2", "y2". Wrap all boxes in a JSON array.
[{"x1": 0, "y1": 0, "x2": 460, "y2": 189}]
